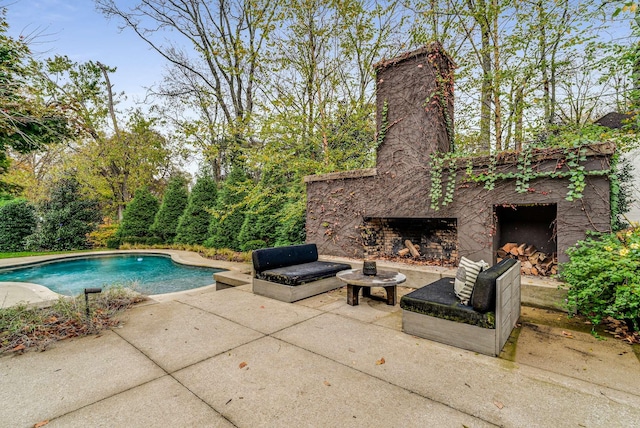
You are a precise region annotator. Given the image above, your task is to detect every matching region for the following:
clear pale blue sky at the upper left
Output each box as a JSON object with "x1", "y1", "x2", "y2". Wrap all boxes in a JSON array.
[{"x1": 5, "y1": 0, "x2": 164, "y2": 107}]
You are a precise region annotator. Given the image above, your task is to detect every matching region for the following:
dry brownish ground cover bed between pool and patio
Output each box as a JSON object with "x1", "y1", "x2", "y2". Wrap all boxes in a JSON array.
[{"x1": 0, "y1": 286, "x2": 146, "y2": 355}]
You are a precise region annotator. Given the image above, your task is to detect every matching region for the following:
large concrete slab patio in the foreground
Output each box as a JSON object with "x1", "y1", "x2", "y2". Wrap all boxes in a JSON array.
[{"x1": 0, "y1": 272, "x2": 640, "y2": 427}]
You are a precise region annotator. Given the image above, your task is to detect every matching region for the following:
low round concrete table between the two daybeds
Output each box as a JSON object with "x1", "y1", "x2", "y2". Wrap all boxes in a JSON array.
[{"x1": 336, "y1": 269, "x2": 407, "y2": 306}]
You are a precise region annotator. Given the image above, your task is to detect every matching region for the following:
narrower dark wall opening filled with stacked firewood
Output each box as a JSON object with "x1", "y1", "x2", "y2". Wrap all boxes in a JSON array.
[{"x1": 494, "y1": 204, "x2": 558, "y2": 276}]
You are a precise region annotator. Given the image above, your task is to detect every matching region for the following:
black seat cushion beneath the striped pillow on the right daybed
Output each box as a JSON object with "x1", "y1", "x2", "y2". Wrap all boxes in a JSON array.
[{"x1": 400, "y1": 278, "x2": 495, "y2": 328}]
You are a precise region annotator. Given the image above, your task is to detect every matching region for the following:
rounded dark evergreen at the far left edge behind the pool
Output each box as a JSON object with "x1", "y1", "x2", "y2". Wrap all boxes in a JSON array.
[{"x1": 0, "y1": 199, "x2": 37, "y2": 251}]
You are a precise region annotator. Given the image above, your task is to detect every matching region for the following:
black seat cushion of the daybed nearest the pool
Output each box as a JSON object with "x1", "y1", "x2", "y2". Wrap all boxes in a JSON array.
[{"x1": 256, "y1": 261, "x2": 351, "y2": 286}]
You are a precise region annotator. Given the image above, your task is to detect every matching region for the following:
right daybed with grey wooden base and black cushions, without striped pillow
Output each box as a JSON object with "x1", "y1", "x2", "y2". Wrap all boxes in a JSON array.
[{"x1": 400, "y1": 259, "x2": 520, "y2": 356}]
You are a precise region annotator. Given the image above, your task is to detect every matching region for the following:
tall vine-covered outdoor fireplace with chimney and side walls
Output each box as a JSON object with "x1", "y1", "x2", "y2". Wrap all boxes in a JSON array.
[{"x1": 305, "y1": 44, "x2": 615, "y2": 274}]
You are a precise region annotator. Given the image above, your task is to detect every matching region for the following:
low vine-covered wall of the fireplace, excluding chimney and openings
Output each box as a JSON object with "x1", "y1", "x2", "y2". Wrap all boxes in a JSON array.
[{"x1": 307, "y1": 158, "x2": 610, "y2": 262}]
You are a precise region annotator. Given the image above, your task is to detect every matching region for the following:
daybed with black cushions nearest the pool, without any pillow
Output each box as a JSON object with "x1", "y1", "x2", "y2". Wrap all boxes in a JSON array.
[{"x1": 252, "y1": 244, "x2": 351, "y2": 302}]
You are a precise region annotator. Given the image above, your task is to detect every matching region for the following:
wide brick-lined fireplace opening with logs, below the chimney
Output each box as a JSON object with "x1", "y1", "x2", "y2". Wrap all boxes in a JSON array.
[{"x1": 361, "y1": 218, "x2": 458, "y2": 266}]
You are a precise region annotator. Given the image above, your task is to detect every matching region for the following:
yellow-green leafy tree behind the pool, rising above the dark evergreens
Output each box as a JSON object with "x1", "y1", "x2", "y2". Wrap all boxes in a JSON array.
[{"x1": 36, "y1": 56, "x2": 178, "y2": 219}]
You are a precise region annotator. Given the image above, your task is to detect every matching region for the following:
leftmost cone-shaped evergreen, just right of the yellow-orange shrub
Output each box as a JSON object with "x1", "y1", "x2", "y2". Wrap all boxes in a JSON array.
[{"x1": 117, "y1": 187, "x2": 159, "y2": 242}]
